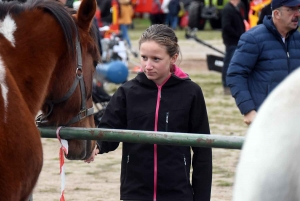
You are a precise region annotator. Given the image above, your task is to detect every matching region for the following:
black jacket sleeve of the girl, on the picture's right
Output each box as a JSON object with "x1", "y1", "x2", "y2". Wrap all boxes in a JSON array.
[{"x1": 190, "y1": 86, "x2": 212, "y2": 201}]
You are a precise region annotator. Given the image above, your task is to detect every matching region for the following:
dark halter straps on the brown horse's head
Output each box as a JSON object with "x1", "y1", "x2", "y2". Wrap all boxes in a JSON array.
[{"x1": 35, "y1": 32, "x2": 94, "y2": 127}]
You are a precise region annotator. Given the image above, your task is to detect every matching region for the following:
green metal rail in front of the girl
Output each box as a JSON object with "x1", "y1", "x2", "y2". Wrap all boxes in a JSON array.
[{"x1": 39, "y1": 127, "x2": 244, "y2": 149}]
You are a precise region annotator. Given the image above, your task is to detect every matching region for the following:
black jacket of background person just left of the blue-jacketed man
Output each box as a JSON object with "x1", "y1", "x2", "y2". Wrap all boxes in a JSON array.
[{"x1": 222, "y1": 2, "x2": 245, "y2": 46}]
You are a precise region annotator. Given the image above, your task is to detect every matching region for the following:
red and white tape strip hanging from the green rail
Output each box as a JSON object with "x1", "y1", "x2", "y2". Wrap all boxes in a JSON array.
[{"x1": 56, "y1": 126, "x2": 68, "y2": 201}]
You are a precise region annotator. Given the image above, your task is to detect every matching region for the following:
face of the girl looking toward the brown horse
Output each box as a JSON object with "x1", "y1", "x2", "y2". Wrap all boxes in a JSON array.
[{"x1": 140, "y1": 41, "x2": 178, "y2": 85}]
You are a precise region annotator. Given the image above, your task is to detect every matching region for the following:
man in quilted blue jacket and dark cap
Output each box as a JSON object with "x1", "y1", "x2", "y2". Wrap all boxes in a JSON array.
[{"x1": 226, "y1": 0, "x2": 300, "y2": 125}]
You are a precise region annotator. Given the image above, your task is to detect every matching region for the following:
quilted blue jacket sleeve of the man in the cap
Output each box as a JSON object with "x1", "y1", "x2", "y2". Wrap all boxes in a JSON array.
[{"x1": 226, "y1": 32, "x2": 259, "y2": 114}]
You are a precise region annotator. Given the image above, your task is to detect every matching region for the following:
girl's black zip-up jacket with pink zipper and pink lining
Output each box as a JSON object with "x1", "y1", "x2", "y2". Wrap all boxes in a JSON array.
[{"x1": 98, "y1": 69, "x2": 212, "y2": 201}]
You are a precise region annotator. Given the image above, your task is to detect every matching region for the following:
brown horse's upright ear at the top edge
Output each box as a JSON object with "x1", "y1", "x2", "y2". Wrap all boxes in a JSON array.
[{"x1": 77, "y1": 0, "x2": 97, "y2": 31}]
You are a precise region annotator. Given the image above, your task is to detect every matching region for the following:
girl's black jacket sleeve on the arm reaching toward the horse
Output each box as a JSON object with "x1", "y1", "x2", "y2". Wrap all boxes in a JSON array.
[{"x1": 97, "y1": 87, "x2": 127, "y2": 154}]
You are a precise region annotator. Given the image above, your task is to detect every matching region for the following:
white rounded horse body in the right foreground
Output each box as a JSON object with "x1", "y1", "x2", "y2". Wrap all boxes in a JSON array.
[{"x1": 233, "y1": 68, "x2": 300, "y2": 201}]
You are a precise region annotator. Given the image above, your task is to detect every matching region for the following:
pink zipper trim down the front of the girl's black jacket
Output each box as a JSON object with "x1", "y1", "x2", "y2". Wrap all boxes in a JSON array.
[{"x1": 153, "y1": 75, "x2": 171, "y2": 201}]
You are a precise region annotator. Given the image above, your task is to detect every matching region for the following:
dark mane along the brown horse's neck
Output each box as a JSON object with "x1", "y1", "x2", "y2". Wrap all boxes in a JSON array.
[{"x1": 0, "y1": 0, "x2": 77, "y2": 56}]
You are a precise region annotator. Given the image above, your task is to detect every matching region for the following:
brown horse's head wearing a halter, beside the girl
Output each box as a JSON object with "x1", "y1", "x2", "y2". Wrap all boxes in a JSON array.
[{"x1": 38, "y1": 0, "x2": 100, "y2": 160}]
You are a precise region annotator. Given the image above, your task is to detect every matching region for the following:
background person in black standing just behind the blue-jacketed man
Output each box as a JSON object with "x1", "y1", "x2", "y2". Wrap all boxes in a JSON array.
[{"x1": 222, "y1": 0, "x2": 245, "y2": 95}]
